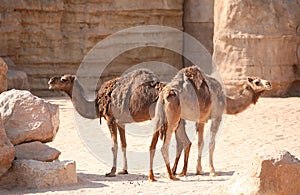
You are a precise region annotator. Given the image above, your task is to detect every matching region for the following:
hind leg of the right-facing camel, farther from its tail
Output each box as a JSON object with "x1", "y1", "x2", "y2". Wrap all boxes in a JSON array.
[{"x1": 161, "y1": 122, "x2": 178, "y2": 181}]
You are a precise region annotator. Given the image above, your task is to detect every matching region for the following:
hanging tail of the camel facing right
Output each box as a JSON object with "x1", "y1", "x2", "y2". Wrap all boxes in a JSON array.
[{"x1": 154, "y1": 96, "x2": 168, "y2": 139}]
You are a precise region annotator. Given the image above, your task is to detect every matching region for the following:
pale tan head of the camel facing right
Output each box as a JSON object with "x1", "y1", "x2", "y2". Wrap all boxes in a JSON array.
[{"x1": 246, "y1": 77, "x2": 272, "y2": 93}]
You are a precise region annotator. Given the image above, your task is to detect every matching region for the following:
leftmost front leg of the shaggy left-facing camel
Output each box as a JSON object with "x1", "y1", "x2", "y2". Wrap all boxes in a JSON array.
[{"x1": 105, "y1": 121, "x2": 118, "y2": 177}]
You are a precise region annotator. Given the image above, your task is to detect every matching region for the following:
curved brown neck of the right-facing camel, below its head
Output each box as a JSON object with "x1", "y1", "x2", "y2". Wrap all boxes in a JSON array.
[{"x1": 226, "y1": 86, "x2": 260, "y2": 114}]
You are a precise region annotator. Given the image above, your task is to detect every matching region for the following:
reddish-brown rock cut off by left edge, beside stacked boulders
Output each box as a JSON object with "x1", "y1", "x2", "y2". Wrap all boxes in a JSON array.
[{"x1": 0, "y1": 114, "x2": 15, "y2": 177}]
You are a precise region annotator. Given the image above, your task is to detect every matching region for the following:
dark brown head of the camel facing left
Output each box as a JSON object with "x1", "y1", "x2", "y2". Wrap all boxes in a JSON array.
[{"x1": 48, "y1": 74, "x2": 76, "y2": 91}]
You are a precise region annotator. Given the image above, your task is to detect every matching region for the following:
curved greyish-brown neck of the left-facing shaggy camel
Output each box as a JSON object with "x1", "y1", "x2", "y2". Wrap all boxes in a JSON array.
[{"x1": 66, "y1": 79, "x2": 99, "y2": 119}]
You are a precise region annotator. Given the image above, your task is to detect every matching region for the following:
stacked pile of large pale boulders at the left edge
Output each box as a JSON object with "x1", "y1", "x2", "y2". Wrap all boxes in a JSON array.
[{"x1": 0, "y1": 90, "x2": 77, "y2": 189}]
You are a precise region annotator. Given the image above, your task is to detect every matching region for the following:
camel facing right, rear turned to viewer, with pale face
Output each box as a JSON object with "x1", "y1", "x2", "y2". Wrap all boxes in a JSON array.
[{"x1": 149, "y1": 66, "x2": 272, "y2": 181}]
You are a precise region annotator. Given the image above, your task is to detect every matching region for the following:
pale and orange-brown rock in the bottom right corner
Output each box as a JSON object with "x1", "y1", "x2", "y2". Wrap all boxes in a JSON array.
[{"x1": 206, "y1": 151, "x2": 300, "y2": 195}]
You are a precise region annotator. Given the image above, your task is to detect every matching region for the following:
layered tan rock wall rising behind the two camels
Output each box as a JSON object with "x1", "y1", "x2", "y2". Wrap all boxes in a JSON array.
[{"x1": 0, "y1": 0, "x2": 300, "y2": 96}]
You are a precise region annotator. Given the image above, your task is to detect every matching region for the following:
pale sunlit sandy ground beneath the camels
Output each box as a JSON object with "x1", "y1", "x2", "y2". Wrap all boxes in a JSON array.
[{"x1": 0, "y1": 97, "x2": 300, "y2": 194}]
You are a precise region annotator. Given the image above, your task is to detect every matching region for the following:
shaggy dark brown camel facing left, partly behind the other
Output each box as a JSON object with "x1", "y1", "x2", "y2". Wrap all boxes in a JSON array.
[{"x1": 48, "y1": 69, "x2": 188, "y2": 177}]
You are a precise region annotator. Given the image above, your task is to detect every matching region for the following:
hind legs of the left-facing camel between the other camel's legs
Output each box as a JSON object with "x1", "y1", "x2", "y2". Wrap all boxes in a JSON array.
[{"x1": 172, "y1": 119, "x2": 192, "y2": 176}]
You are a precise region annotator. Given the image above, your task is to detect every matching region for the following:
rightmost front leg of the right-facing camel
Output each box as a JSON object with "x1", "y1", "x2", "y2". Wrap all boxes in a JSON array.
[{"x1": 209, "y1": 118, "x2": 222, "y2": 176}]
